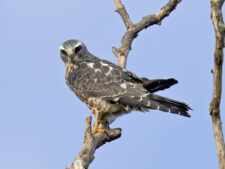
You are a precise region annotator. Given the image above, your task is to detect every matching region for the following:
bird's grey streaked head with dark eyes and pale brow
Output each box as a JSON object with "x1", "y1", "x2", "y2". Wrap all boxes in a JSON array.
[{"x1": 60, "y1": 39, "x2": 89, "y2": 64}]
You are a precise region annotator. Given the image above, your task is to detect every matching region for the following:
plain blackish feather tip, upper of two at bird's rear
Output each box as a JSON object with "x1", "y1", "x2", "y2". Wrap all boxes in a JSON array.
[{"x1": 141, "y1": 78, "x2": 178, "y2": 93}]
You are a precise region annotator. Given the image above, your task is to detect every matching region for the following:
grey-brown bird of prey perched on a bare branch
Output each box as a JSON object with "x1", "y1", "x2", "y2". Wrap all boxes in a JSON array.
[{"x1": 60, "y1": 39, "x2": 191, "y2": 134}]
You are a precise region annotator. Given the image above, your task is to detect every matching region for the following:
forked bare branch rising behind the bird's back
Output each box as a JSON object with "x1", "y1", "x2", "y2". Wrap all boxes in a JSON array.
[{"x1": 113, "y1": 0, "x2": 181, "y2": 68}]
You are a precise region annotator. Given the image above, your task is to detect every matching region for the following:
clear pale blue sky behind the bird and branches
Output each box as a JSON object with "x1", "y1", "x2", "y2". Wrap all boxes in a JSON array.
[{"x1": 0, "y1": 0, "x2": 225, "y2": 169}]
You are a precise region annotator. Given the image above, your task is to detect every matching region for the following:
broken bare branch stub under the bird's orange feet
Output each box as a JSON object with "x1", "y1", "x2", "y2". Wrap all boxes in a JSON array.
[{"x1": 66, "y1": 116, "x2": 121, "y2": 169}]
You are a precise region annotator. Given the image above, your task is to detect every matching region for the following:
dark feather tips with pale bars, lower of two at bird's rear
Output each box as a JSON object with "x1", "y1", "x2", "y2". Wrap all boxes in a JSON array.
[{"x1": 149, "y1": 94, "x2": 191, "y2": 117}]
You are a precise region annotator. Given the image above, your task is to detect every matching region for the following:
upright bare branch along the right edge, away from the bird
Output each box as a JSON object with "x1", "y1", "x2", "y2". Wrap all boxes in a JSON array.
[{"x1": 210, "y1": 0, "x2": 225, "y2": 169}]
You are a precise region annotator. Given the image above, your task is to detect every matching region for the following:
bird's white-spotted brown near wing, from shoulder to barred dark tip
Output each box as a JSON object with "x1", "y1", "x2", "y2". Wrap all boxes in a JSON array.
[{"x1": 68, "y1": 60, "x2": 190, "y2": 117}]
